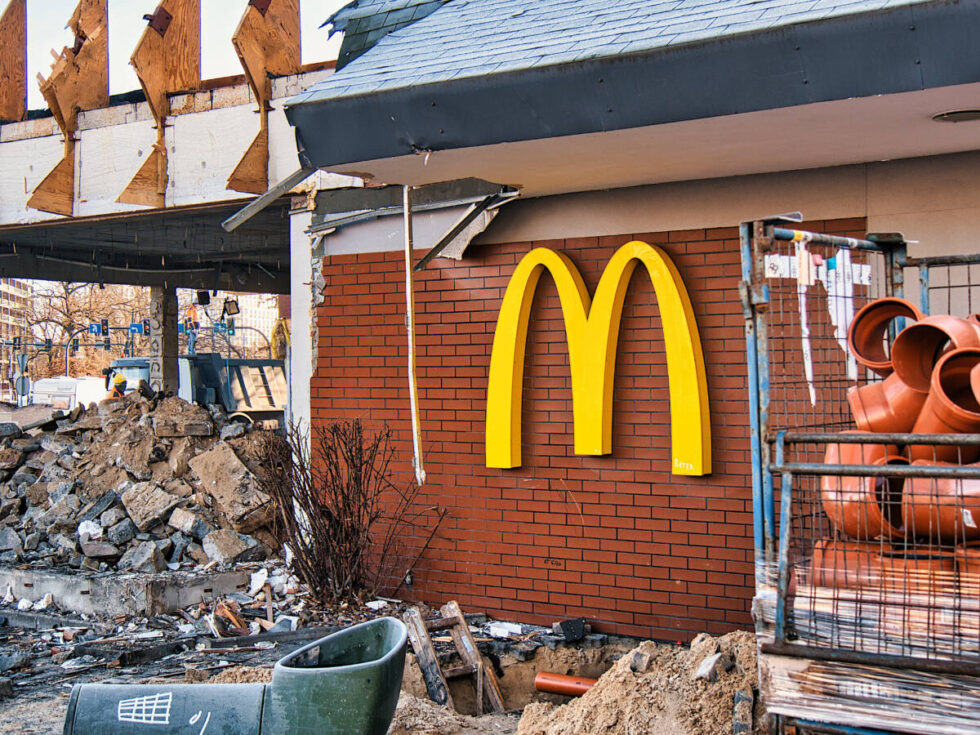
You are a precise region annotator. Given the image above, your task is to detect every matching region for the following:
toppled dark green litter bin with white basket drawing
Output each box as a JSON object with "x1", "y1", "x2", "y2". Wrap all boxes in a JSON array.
[{"x1": 63, "y1": 618, "x2": 408, "y2": 735}]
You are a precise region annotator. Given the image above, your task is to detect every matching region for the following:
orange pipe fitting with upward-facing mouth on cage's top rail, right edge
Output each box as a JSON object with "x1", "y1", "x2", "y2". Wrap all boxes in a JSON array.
[{"x1": 908, "y1": 347, "x2": 980, "y2": 464}]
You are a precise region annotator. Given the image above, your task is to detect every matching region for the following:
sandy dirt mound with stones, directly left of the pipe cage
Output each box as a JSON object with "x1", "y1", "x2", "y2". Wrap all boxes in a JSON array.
[{"x1": 517, "y1": 631, "x2": 764, "y2": 735}]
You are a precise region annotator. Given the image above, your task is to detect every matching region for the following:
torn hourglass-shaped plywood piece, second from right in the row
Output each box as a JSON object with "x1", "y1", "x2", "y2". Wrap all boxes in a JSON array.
[{"x1": 116, "y1": 0, "x2": 201, "y2": 207}]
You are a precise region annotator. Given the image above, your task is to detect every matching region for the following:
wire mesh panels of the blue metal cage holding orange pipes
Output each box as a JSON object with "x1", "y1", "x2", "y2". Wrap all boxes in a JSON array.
[{"x1": 760, "y1": 233, "x2": 980, "y2": 660}]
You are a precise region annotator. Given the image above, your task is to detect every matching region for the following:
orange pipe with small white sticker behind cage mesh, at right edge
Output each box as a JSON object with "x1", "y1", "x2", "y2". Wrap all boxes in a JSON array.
[{"x1": 902, "y1": 460, "x2": 980, "y2": 544}]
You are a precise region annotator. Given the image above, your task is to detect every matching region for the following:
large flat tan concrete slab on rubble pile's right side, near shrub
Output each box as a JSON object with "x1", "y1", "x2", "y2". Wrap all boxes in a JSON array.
[{"x1": 189, "y1": 442, "x2": 273, "y2": 533}]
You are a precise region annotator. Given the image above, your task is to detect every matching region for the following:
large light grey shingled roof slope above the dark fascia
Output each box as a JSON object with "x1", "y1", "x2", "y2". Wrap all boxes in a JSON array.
[{"x1": 290, "y1": 0, "x2": 927, "y2": 104}]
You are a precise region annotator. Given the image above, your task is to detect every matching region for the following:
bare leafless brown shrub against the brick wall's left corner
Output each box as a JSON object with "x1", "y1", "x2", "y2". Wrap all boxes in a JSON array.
[{"x1": 263, "y1": 419, "x2": 428, "y2": 604}]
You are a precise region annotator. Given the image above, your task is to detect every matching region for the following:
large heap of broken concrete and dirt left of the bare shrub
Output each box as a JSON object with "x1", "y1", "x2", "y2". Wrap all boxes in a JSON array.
[{"x1": 0, "y1": 392, "x2": 277, "y2": 572}]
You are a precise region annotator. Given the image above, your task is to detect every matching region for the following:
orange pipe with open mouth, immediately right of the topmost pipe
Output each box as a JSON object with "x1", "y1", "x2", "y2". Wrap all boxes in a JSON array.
[{"x1": 892, "y1": 314, "x2": 980, "y2": 393}]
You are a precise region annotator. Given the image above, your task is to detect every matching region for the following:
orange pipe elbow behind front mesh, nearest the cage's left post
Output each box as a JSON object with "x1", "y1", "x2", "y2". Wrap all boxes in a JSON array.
[{"x1": 820, "y1": 432, "x2": 908, "y2": 539}]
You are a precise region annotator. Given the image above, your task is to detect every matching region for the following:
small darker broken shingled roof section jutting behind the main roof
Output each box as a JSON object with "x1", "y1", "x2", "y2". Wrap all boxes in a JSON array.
[{"x1": 320, "y1": 0, "x2": 449, "y2": 71}]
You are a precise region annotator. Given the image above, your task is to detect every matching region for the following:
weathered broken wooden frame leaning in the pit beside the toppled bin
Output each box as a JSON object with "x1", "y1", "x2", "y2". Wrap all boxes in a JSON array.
[{"x1": 405, "y1": 600, "x2": 504, "y2": 714}]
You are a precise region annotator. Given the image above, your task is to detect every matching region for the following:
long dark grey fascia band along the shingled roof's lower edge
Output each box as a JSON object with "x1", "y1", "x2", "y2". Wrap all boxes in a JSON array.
[{"x1": 286, "y1": 0, "x2": 980, "y2": 168}]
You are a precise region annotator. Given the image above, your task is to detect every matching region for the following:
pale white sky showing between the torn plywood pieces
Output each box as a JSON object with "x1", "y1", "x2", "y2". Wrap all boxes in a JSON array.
[{"x1": 25, "y1": 0, "x2": 348, "y2": 110}]
